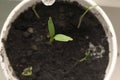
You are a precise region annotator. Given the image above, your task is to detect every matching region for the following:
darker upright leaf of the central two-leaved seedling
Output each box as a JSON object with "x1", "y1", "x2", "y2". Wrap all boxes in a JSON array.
[{"x1": 48, "y1": 17, "x2": 55, "y2": 37}]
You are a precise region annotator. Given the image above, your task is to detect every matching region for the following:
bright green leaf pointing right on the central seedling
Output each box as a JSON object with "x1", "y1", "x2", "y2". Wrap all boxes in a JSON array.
[{"x1": 54, "y1": 34, "x2": 73, "y2": 42}]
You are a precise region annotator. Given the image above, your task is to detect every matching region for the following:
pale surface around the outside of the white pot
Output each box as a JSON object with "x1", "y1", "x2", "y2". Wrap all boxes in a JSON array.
[{"x1": 0, "y1": 0, "x2": 120, "y2": 80}]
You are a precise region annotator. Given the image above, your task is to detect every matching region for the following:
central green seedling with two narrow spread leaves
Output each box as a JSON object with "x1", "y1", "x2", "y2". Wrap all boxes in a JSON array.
[{"x1": 48, "y1": 17, "x2": 73, "y2": 42}]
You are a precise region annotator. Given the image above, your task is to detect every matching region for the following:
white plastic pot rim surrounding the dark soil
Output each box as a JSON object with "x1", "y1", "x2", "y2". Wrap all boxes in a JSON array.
[{"x1": 0, "y1": 0, "x2": 117, "y2": 80}]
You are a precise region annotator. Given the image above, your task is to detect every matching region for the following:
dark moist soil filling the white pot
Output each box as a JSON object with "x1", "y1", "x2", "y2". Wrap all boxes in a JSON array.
[{"x1": 5, "y1": 2, "x2": 109, "y2": 80}]
